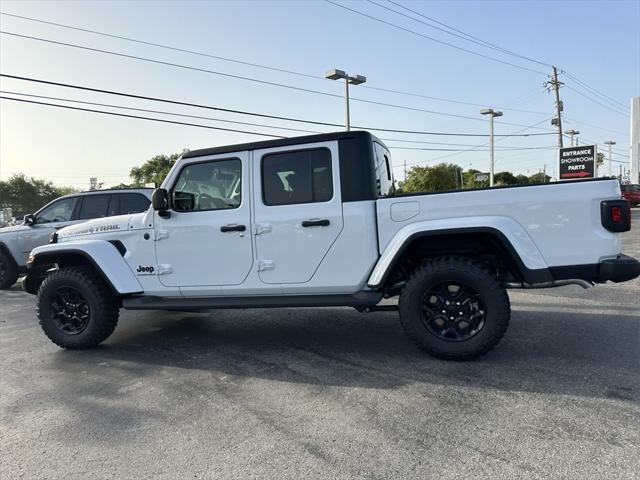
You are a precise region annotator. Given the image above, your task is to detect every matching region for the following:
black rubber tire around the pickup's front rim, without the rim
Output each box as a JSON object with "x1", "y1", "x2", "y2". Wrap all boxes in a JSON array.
[{"x1": 37, "y1": 267, "x2": 119, "y2": 350}]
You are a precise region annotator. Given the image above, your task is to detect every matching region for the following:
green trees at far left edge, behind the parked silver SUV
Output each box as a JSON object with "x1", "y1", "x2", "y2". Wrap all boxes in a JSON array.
[{"x1": 0, "y1": 174, "x2": 77, "y2": 216}]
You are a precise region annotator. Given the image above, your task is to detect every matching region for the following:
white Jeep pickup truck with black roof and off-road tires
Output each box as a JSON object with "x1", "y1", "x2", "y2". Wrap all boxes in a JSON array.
[{"x1": 24, "y1": 132, "x2": 640, "y2": 360}]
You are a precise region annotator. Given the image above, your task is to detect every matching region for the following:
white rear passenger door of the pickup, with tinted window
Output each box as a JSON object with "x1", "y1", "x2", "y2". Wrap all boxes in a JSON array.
[{"x1": 253, "y1": 141, "x2": 343, "y2": 284}]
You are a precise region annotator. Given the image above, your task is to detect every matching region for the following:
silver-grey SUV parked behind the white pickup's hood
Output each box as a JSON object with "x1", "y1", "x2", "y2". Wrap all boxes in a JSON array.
[{"x1": 0, "y1": 188, "x2": 153, "y2": 289}]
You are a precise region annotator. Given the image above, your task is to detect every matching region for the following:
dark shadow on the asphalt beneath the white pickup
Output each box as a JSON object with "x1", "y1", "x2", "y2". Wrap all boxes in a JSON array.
[{"x1": 51, "y1": 309, "x2": 640, "y2": 402}]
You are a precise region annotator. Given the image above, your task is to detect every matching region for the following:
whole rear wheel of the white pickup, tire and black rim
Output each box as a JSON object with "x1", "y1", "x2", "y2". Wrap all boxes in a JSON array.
[{"x1": 399, "y1": 256, "x2": 511, "y2": 360}]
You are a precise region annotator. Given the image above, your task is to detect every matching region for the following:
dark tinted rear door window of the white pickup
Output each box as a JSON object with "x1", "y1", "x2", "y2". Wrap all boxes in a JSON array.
[{"x1": 262, "y1": 148, "x2": 333, "y2": 205}]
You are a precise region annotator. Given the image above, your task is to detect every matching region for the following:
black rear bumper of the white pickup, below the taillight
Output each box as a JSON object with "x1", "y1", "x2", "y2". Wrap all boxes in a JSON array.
[{"x1": 549, "y1": 254, "x2": 640, "y2": 283}]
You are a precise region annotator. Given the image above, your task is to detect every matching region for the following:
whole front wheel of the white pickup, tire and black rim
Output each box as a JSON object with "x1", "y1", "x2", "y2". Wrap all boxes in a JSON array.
[{"x1": 38, "y1": 267, "x2": 119, "y2": 349}]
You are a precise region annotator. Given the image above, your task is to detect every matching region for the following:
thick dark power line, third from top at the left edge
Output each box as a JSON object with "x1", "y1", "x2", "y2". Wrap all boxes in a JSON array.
[{"x1": 0, "y1": 73, "x2": 551, "y2": 137}]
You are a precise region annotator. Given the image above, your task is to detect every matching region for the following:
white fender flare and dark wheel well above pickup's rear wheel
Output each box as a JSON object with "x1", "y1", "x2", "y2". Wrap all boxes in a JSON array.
[{"x1": 368, "y1": 226, "x2": 553, "y2": 288}]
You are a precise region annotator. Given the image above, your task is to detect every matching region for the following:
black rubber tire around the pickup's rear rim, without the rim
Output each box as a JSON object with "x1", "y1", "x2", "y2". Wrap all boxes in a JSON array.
[{"x1": 399, "y1": 256, "x2": 511, "y2": 360}]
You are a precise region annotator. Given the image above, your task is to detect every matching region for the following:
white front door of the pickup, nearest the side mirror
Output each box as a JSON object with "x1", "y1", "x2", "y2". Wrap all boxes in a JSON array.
[{"x1": 154, "y1": 152, "x2": 253, "y2": 287}]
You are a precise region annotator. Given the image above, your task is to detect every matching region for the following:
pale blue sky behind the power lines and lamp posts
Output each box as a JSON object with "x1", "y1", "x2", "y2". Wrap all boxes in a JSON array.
[{"x1": 0, "y1": 0, "x2": 640, "y2": 188}]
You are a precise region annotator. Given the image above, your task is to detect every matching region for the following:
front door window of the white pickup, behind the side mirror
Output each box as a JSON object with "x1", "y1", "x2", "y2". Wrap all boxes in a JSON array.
[{"x1": 172, "y1": 158, "x2": 242, "y2": 212}]
